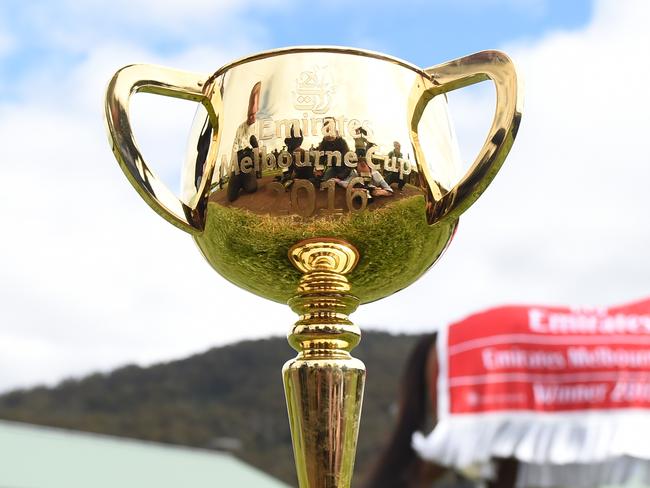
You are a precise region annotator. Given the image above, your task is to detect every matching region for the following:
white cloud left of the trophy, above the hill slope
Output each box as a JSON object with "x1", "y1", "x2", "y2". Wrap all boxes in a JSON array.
[{"x1": 0, "y1": 5, "x2": 292, "y2": 390}]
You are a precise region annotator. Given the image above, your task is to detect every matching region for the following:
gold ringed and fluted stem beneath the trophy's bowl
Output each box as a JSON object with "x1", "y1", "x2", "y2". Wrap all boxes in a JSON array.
[{"x1": 282, "y1": 238, "x2": 366, "y2": 488}]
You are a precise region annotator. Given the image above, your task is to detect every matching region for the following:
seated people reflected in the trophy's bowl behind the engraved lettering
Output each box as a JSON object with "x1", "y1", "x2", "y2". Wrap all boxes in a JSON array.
[{"x1": 196, "y1": 82, "x2": 419, "y2": 215}]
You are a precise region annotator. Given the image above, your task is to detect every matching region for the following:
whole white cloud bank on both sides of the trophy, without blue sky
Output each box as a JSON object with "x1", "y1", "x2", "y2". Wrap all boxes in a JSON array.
[{"x1": 0, "y1": 0, "x2": 650, "y2": 389}]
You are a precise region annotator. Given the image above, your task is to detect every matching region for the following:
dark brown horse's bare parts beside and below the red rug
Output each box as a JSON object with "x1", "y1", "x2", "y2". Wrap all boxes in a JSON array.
[{"x1": 365, "y1": 334, "x2": 518, "y2": 488}]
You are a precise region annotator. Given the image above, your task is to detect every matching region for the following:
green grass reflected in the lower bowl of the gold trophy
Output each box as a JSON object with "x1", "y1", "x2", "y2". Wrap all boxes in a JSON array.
[{"x1": 195, "y1": 195, "x2": 455, "y2": 303}]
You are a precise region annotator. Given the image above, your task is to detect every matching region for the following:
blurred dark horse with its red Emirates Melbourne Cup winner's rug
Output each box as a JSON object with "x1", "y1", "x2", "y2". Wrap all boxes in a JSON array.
[{"x1": 366, "y1": 299, "x2": 650, "y2": 488}]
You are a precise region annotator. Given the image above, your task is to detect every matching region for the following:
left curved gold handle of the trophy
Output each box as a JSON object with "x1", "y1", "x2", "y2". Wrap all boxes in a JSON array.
[{"x1": 105, "y1": 64, "x2": 222, "y2": 234}]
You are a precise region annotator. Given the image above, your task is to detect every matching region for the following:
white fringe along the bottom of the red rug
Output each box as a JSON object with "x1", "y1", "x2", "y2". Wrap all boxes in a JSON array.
[{"x1": 413, "y1": 410, "x2": 650, "y2": 487}]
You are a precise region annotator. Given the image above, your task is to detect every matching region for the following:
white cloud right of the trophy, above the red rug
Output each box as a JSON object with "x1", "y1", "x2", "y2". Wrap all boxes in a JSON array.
[{"x1": 357, "y1": 0, "x2": 650, "y2": 330}]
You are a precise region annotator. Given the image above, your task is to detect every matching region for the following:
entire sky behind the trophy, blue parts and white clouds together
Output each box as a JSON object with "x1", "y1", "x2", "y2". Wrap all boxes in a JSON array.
[{"x1": 0, "y1": 0, "x2": 650, "y2": 391}]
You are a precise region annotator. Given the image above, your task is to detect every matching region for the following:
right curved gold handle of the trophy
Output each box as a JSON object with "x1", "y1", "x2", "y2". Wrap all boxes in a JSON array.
[{"x1": 412, "y1": 51, "x2": 522, "y2": 220}]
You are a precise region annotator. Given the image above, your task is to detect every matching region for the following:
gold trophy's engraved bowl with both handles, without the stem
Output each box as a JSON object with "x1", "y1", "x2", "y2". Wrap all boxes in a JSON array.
[{"x1": 106, "y1": 47, "x2": 521, "y2": 303}]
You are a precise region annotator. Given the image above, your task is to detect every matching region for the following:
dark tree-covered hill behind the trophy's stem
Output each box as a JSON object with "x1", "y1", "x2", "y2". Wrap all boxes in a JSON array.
[{"x1": 0, "y1": 332, "x2": 419, "y2": 485}]
